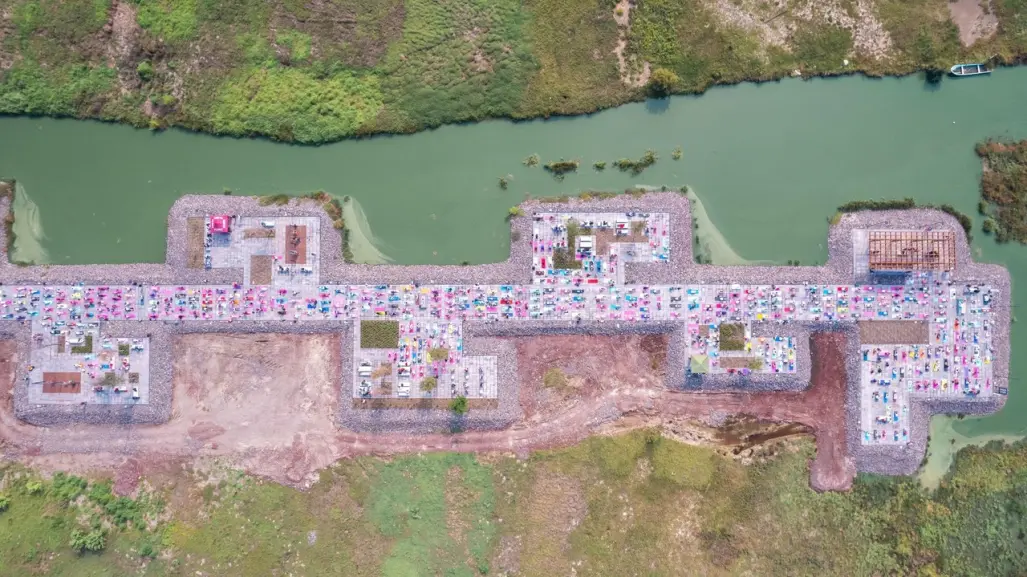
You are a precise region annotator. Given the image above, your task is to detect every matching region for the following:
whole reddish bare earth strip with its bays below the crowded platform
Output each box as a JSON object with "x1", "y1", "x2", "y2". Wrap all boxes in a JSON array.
[{"x1": 0, "y1": 333, "x2": 855, "y2": 488}]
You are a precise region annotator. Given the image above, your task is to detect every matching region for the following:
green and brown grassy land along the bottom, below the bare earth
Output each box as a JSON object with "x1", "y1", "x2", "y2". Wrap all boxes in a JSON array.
[{"x1": 6, "y1": 431, "x2": 1027, "y2": 577}]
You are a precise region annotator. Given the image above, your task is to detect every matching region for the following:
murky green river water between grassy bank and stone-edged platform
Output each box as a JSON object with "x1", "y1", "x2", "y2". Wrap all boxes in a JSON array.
[{"x1": 0, "y1": 68, "x2": 1027, "y2": 470}]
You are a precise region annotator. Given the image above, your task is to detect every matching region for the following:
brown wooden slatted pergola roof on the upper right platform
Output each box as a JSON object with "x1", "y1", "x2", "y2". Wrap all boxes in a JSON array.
[{"x1": 868, "y1": 230, "x2": 956, "y2": 272}]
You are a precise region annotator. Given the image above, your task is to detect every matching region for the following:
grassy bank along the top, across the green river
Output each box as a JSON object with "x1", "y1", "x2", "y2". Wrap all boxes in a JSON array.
[{"x1": 0, "y1": 0, "x2": 1027, "y2": 143}]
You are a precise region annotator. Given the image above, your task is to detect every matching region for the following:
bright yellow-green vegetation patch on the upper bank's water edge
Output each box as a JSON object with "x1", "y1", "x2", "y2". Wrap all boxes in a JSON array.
[{"x1": 211, "y1": 68, "x2": 382, "y2": 143}]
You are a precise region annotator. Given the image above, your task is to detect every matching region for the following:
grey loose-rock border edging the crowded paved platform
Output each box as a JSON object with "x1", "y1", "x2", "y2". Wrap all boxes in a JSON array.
[{"x1": 0, "y1": 192, "x2": 1011, "y2": 474}]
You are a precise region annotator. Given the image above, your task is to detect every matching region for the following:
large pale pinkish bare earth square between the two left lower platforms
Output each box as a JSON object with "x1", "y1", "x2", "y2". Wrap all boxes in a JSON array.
[{"x1": 168, "y1": 335, "x2": 341, "y2": 484}]
